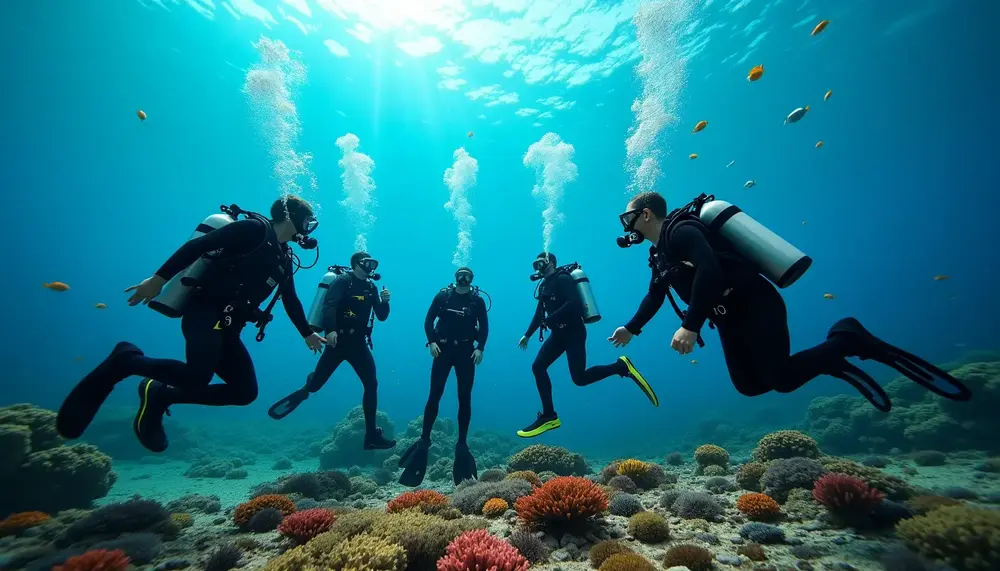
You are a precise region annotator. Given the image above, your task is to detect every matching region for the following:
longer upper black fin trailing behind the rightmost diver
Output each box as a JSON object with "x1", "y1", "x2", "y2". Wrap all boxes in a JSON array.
[{"x1": 826, "y1": 317, "x2": 972, "y2": 401}]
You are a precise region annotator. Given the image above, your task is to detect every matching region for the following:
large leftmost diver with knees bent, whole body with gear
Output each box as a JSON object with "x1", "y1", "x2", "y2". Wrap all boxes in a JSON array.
[{"x1": 56, "y1": 196, "x2": 324, "y2": 452}]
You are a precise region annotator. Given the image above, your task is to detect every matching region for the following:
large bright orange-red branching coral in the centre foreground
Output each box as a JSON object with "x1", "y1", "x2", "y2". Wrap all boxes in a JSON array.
[{"x1": 514, "y1": 476, "x2": 608, "y2": 527}]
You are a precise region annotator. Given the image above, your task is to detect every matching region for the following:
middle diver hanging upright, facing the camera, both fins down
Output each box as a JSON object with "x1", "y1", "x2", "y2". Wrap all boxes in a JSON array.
[{"x1": 399, "y1": 267, "x2": 490, "y2": 487}]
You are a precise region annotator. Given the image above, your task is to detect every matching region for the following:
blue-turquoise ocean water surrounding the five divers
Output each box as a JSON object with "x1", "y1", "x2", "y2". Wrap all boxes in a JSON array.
[{"x1": 0, "y1": 0, "x2": 1000, "y2": 455}]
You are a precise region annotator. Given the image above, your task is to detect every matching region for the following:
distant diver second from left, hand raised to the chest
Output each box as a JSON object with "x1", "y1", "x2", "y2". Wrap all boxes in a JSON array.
[{"x1": 268, "y1": 252, "x2": 396, "y2": 450}]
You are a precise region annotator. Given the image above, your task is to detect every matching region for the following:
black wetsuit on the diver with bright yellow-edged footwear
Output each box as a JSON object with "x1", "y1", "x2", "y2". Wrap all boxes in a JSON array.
[{"x1": 524, "y1": 271, "x2": 628, "y2": 416}]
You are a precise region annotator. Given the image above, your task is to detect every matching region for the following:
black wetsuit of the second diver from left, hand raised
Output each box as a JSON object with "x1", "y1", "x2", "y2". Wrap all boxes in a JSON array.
[{"x1": 306, "y1": 272, "x2": 389, "y2": 434}]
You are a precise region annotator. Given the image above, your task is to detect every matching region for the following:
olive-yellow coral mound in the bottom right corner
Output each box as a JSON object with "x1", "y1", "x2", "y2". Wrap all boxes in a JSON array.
[{"x1": 896, "y1": 505, "x2": 1000, "y2": 571}]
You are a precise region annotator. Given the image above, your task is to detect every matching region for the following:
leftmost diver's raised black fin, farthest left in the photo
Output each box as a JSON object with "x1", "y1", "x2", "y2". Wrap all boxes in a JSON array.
[{"x1": 56, "y1": 341, "x2": 142, "y2": 439}]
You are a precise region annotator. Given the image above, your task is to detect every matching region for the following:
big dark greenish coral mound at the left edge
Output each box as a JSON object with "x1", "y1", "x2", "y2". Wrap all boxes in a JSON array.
[{"x1": 0, "y1": 404, "x2": 118, "y2": 517}]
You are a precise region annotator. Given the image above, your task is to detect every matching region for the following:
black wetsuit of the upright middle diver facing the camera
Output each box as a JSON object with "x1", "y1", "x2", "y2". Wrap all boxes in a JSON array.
[{"x1": 422, "y1": 287, "x2": 490, "y2": 443}]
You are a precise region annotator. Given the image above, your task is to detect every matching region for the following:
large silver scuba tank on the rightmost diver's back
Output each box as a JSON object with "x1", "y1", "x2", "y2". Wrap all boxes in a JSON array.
[{"x1": 698, "y1": 200, "x2": 812, "y2": 288}]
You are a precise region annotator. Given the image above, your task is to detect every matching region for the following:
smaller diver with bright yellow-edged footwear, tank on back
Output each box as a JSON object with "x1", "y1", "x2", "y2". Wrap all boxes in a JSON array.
[{"x1": 517, "y1": 252, "x2": 660, "y2": 438}]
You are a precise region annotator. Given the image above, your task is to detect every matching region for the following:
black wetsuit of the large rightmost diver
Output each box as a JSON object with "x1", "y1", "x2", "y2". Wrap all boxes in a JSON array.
[{"x1": 625, "y1": 218, "x2": 852, "y2": 396}]
